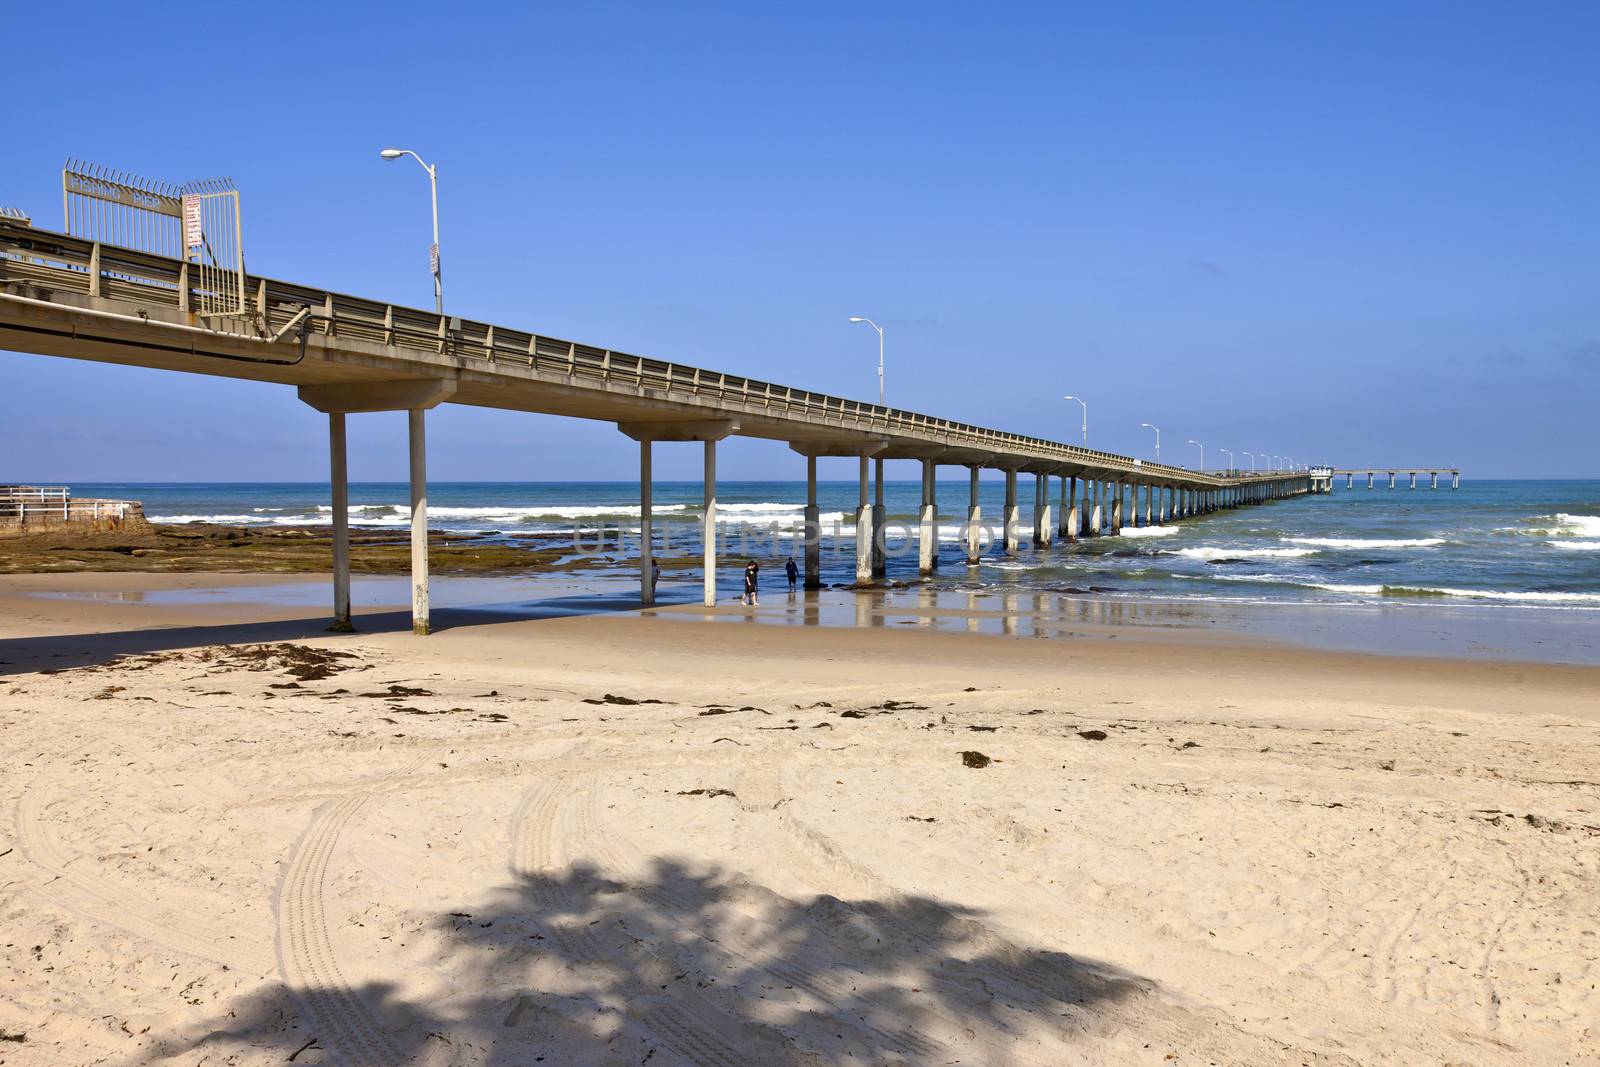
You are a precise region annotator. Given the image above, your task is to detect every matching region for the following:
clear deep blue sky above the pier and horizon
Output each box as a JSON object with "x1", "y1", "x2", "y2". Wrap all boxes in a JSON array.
[{"x1": 0, "y1": 0, "x2": 1600, "y2": 482}]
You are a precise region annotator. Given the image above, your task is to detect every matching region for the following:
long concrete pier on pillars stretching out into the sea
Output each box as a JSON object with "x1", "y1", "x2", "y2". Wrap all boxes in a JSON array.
[{"x1": 0, "y1": 218, "x2": 1350, "y2": 633}]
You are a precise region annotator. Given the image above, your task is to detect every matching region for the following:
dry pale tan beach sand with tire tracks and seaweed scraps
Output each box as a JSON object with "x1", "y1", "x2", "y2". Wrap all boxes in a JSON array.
[{"x1": 0, "y1": 576, "x2": 1600, "y2": 1067}]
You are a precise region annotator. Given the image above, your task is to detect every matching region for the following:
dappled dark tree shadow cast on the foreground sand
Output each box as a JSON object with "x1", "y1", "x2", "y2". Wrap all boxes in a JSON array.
[{"x1": 162, "y1": 861, "x2": 1214, "y2": 1067}]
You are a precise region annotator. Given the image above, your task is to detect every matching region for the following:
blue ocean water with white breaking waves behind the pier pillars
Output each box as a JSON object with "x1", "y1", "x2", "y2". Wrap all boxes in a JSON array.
[{"x1": 72, "y1": 477, "x2": 1600, "y2": 613}]
